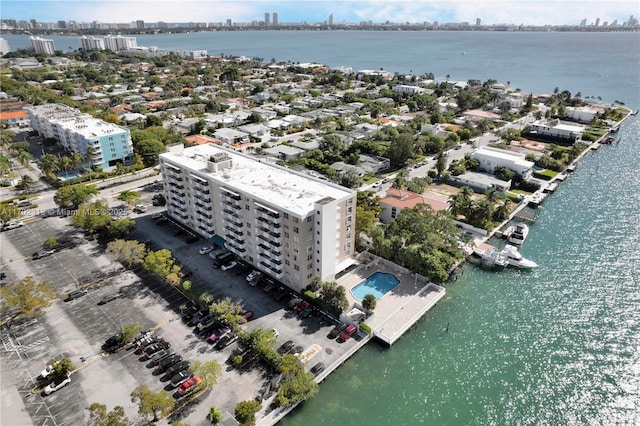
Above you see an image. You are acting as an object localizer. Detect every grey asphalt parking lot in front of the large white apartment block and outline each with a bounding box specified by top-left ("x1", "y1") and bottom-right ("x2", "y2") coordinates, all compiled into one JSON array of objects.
[{"x1": 0, "y1": 205, "x2": 362, "y2": 425}]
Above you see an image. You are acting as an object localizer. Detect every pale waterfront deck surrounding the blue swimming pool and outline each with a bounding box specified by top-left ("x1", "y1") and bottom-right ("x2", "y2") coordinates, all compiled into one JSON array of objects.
[{"x1": 337, "y1": 253, "x2": 445, "y2": 345}]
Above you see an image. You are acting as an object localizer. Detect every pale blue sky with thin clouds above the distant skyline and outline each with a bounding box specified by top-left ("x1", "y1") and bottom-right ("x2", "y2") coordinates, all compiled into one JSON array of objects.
[{"x1": 0, "y1": 0, "x2": 640, "y2": 25}]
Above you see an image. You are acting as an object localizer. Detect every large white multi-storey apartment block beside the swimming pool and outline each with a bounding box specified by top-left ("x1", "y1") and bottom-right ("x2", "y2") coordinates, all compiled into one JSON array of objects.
[{"x1": 160, "y1": 144, "x2": 357, "y2": 291}]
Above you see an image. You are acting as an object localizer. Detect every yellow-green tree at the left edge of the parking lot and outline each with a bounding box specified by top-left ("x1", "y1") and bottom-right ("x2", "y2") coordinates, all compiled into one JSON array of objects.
[{"x1": 0, "y1": 275, "x2": 56, "y2": 318}]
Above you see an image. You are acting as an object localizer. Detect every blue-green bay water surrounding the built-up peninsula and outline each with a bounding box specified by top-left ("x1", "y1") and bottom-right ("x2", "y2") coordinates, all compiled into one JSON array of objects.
[{"x1": 3, "y1": 32, "x2": 640, "y2": 426}]
